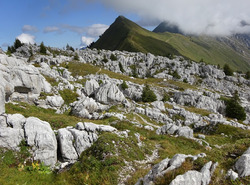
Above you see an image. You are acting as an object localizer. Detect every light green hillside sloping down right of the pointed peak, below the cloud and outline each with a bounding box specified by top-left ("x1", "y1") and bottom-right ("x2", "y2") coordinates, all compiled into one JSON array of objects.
[{"x1": 155, "y1": 32, "x2": 250, "y2": 71}]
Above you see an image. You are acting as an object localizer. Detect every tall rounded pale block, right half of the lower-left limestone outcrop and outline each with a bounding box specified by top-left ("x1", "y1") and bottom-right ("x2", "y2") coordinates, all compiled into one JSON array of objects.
[{"x1": 24, "y1": 117, "x2": 57, "y2": 166}]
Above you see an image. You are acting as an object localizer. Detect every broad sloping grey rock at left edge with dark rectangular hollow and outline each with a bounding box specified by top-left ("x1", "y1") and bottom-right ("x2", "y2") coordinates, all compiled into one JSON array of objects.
[{"x1": 0, "y1": 54, "x2": 51, "y2": 99}]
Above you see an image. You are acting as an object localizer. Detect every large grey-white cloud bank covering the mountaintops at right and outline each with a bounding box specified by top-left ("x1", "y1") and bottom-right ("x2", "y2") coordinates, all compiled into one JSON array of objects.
[{"x1": 97, "y1": 0, "x2": 250, "y2": 35}]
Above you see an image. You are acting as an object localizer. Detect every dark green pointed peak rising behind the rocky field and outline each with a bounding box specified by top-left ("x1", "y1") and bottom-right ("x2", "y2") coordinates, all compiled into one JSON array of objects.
[{"x1": 92, "y1": 16, "x2": 180, "y2": 56}]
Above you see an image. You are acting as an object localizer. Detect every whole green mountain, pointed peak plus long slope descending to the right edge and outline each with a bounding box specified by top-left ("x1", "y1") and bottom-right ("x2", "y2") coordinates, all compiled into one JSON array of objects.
[{"x1": 92, "y1": 16, "x2": 250, "y2": 71}]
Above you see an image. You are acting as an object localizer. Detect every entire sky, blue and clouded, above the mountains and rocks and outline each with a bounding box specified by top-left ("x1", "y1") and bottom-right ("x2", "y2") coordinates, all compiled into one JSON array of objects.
[{"x1": 0, "y1": 0, "x2": 250, "y2": 49}]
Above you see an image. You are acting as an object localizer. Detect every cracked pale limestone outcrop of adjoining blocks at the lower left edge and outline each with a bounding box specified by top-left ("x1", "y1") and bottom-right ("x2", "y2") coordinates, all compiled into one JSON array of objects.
[{"x1": 0, "y1": 114, "x2": 57, "y2": 166}]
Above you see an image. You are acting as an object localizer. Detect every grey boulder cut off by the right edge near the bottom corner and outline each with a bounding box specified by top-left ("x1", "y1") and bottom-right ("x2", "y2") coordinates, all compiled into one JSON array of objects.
[{"x1": 234, "y1": 147, "x2": 250, "y2": 177}]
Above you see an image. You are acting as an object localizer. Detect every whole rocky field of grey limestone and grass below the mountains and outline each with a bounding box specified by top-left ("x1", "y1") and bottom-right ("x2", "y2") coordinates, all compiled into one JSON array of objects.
[{"x1": 0, "y1": 44, "x2": 250, "y2": 185}]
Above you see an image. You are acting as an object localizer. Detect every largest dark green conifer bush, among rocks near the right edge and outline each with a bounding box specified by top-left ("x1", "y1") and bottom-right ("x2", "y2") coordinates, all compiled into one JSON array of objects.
[{"x1": 226, "y1": 91, "x2": 246, "y2": 120}]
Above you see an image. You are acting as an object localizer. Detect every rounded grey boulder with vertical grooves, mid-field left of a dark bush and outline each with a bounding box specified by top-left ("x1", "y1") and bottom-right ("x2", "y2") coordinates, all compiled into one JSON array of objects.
[{"x1": 95, "y1": 83, "x2": 125, "y2": 104}]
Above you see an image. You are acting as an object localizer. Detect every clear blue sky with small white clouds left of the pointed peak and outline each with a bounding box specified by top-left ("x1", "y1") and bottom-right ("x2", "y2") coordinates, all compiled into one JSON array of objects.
[{"x1": 0, "y1": 0, "x2": 141, "y2": 49}]
